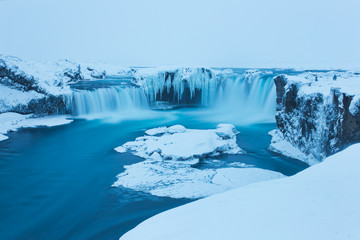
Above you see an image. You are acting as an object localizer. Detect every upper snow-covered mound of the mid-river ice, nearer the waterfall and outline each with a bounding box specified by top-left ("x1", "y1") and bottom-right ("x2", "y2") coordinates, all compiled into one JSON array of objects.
[{"x1": 115, "y1": 124, "x2": 242, "y2": 160}]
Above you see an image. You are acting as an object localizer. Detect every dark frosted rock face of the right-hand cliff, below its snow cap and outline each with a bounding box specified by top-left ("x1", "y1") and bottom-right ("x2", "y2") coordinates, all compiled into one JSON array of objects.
[{"x1": 274, "y1": 76, "x2": 360, "y2": 160}]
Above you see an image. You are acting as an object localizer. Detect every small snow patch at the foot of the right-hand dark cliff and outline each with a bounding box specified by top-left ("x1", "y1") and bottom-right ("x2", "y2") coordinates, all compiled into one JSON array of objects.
[{"x1": 269, "y1": 129, "x2": 319, "y2": 165}]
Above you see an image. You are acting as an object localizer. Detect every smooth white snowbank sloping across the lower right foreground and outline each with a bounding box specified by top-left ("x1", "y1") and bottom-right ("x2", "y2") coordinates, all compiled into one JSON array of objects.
[{"x1": 120, "y1": 144, "x2": 360, "y2": 240}]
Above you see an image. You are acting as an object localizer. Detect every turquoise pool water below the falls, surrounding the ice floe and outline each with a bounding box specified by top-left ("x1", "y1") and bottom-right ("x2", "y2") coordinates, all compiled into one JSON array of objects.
[{"x1": 0, "y1": 109, "x2": 307, "y2": 240}]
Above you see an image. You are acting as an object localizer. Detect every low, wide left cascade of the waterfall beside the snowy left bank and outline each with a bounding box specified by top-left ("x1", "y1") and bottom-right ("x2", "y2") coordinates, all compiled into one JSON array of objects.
[{"x1": 66, "y1": 86, "x2": 148, "y2": 116}]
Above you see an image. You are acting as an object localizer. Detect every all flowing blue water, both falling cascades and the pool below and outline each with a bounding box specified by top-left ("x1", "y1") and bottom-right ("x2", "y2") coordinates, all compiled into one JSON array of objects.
[{"x1": 0, "y1": 68, "x2": 307, "y2": 240}]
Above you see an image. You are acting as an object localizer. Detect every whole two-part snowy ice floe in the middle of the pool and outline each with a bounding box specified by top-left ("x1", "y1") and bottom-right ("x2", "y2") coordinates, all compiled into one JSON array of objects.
[{"x1": 113, "y1": 124, "x2": 283, "y2": 198}]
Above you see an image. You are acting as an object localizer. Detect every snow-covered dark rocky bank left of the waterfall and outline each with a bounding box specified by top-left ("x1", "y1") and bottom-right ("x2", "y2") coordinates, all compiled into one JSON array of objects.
[{"x1": 0, "y1": 54, "x2": 130, "y2": 116}]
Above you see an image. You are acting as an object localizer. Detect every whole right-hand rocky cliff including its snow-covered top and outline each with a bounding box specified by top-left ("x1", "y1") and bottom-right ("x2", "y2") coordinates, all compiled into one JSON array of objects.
[{"x1": 274, "y1": 72, "x2": 360, "y2": 160}]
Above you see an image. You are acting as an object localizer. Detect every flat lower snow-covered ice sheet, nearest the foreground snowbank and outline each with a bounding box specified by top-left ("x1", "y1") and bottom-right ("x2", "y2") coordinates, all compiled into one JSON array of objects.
[{"x1": 113, "y1": 159, "x2": 283, "y2": 198}]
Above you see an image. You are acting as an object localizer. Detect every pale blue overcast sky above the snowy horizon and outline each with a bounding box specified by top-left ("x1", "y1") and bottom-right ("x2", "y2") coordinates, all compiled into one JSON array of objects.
[{"x1": 0, "y1": 0, "x2": 360, "y2": 68}]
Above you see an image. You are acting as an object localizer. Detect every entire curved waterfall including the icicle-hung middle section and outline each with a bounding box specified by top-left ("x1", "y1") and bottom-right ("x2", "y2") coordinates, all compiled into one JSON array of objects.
[{"x1": 66, "y1": 68, "x2": 276, "y2": 122}]
